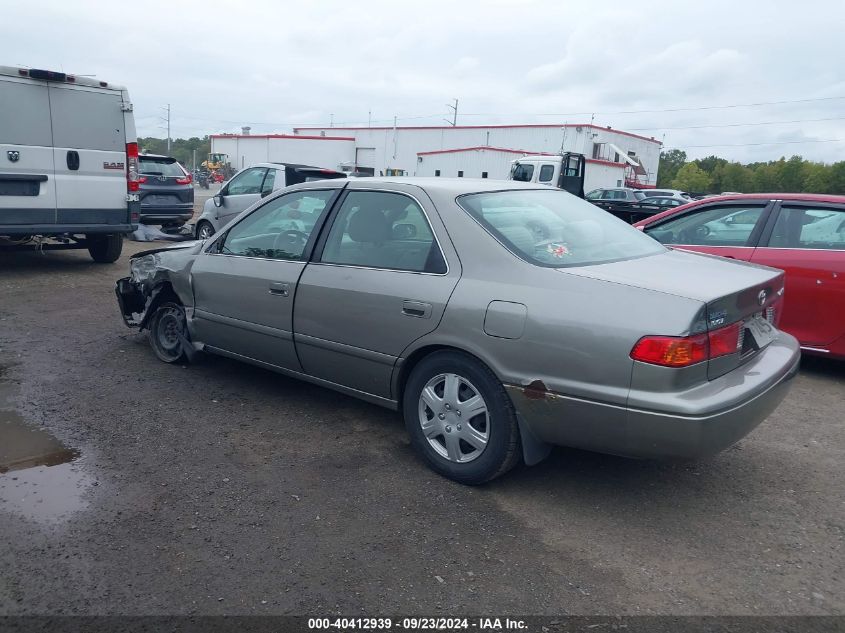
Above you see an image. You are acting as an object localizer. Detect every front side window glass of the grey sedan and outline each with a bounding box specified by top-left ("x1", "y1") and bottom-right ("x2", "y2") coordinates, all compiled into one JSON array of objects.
[{"x1": 218, "y1": 190, "x2": 334, "y2": 261}]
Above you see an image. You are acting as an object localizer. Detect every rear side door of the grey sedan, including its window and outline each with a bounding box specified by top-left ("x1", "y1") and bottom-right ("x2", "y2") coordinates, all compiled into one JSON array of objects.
[{"x1": 294, "y1": 185, "x2": 460, "y2": 398}]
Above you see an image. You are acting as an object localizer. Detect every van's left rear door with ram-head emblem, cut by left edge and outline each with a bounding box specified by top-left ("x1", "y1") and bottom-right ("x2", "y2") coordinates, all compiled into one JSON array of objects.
[{"x1": 0, "y1": 75, "x2": 56, "y2": 228}]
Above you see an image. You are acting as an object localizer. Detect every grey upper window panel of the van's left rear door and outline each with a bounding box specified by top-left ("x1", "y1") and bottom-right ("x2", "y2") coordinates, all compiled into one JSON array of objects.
[{"x1": 0, "y1": 78, "x2": 53, "y2": 146}]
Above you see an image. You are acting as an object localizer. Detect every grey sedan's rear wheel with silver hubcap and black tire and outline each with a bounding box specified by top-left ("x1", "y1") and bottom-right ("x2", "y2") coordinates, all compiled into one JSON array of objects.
[{"x1": 402, "y1": 351, "x2": 522, "y2": 485}]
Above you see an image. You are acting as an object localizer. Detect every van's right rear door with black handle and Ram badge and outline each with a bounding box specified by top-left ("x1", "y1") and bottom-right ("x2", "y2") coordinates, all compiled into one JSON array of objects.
[{"x1": 50, "y1": 83, "x2": 127, "y2": 232}]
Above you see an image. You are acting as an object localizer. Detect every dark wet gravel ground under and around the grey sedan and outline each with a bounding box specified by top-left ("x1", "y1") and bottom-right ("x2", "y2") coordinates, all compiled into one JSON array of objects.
[{"x1": 0, "y1": 235, "x2": 845, "y2": 615}]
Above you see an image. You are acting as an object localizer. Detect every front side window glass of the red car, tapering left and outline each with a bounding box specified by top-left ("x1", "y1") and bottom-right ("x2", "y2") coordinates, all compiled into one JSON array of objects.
[{"x1": 645, "y1": 204, "x2": 765, "y2": 246}]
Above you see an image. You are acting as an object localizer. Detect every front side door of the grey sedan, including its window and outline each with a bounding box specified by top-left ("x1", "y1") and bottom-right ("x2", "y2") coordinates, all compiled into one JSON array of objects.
[{"x1": 191, "y1": 188, "x2": 340, "y2": 371}]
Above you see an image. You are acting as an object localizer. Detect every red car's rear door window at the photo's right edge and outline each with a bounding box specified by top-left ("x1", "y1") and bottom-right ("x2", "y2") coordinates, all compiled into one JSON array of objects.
[{"x1": 769, "y1": 207, "x2": 845, "y2": 251}]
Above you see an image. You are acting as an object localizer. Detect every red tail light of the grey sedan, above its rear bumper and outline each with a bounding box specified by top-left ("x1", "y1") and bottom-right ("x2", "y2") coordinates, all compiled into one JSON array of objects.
[{"x1": 631, "y1": 323, "x2": 742, "y2": 367}]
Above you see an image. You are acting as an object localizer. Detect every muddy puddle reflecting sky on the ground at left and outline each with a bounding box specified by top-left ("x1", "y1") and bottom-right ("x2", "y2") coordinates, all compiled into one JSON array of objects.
[{"x1": 0, "y1": 410, "x2": 96, "y2": 523}]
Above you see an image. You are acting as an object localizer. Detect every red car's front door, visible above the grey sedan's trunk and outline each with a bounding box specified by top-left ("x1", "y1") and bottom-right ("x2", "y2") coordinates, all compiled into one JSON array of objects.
[{"x1": 645, "y1": 200, "x2": 772, "y2": 261}]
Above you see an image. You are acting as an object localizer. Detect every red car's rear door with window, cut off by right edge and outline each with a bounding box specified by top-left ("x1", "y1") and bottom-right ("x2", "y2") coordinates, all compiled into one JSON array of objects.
[{"x1": 751, "y1": 201, "x2": 845, "y2": 347}]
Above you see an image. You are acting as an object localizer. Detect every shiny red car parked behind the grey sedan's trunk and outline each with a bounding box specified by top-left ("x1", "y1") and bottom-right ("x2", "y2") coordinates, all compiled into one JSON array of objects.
[{"x1": 634, "y1": 193, "x2": 845, "y2": 359}]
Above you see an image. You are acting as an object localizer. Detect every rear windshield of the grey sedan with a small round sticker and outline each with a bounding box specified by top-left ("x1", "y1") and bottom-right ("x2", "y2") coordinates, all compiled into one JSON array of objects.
[{"x1": 458, "y1": 189, "x2": 666, "y2": 268}]
